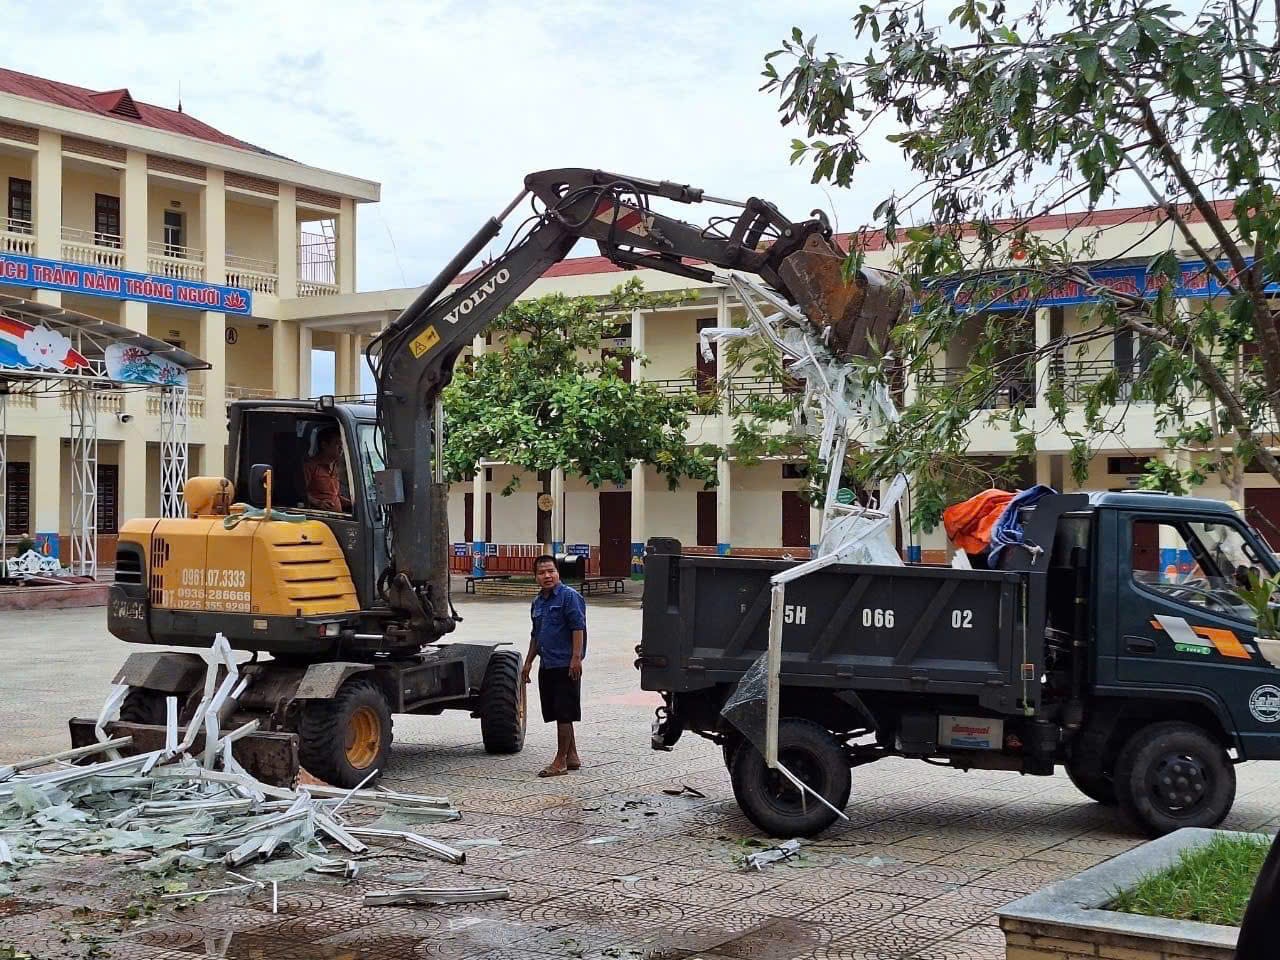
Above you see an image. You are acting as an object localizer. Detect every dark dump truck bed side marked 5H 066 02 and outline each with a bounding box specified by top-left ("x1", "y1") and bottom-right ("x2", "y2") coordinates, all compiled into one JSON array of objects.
[{"x1": 640, "y1": 540, "x2": 1043, "y2": 714}]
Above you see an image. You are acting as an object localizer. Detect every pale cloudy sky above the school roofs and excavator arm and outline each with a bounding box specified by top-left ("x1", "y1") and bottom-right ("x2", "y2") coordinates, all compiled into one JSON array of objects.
[{"x1": 0, "y1": 0, "x2": 911, "y2": 291}]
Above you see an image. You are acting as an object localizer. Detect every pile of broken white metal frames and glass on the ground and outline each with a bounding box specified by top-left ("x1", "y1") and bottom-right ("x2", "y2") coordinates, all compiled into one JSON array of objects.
[{"x1": 0, "y1": 635, "x2": 507, "y2": 905}]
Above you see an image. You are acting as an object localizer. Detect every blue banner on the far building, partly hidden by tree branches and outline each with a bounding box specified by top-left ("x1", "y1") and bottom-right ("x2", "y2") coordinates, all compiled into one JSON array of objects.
[{"x1": 943, "y1": 260, "x2": 1259, "y2": 310}]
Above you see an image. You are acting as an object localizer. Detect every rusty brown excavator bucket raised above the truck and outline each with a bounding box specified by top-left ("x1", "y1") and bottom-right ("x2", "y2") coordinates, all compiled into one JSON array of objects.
[{"x1": 778, "y1": 234, "x2": 906, "y2": 360}]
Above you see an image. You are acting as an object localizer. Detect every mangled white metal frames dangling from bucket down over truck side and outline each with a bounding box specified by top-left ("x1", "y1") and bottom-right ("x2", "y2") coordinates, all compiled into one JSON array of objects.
[{"x1": 700, "y1": 274, "x2": 908, "y2": 798}]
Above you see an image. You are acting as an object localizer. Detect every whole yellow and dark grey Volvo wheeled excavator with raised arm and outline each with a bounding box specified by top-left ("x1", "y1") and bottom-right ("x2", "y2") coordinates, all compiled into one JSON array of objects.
[{"x1": 70, "y1": 168, "x2": 902, "y2": 787}]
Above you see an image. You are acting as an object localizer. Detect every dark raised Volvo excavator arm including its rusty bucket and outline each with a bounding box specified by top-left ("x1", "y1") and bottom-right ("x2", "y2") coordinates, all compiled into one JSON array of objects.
[{"x1": 369, "y1": 168, "x2": 901, "y2": 643}]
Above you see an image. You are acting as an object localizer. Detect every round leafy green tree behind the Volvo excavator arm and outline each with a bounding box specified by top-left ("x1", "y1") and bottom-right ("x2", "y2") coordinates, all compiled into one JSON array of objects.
[{"x1": 444, "y1": 273, "x2": 718, "y2": 494}]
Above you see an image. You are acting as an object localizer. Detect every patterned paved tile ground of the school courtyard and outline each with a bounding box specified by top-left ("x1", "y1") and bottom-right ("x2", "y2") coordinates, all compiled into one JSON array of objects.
[{"x1": 0, "y1": 591, "x2": 1280, "y2": 960}]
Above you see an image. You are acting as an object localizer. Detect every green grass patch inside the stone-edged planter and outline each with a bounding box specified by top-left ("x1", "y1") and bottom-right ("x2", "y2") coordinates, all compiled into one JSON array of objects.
[{"x1": 1107, "y1": 836, "x2": 1271, "y2": 927}]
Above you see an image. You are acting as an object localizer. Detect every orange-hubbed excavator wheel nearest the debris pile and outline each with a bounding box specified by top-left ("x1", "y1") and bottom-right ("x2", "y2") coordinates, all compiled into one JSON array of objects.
[{"x1": 298, "y1": 677, "x2": 392, "y2": 787}]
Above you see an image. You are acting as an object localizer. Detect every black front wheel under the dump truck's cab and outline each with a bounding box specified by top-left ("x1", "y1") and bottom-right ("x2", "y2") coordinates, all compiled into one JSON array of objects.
[{"x1": 1115, "y1": 721, "x2": 1235, "y2": 836}]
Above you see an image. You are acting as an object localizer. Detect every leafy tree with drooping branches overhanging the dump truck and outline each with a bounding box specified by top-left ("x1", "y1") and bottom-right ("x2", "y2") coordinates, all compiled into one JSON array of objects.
[{"x1": 763, "y1": 0, "x2": 1280, "y2": 525}]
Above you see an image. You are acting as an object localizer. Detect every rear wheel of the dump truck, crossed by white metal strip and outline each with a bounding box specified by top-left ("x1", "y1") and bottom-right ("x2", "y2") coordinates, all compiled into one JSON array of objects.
[{"x1": 730, "y1": 719, "x2": 852, "y2": 837}]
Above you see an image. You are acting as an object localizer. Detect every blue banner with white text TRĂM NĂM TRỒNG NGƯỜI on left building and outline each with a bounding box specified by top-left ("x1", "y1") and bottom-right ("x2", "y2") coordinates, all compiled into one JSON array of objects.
[{"x1": 0, "y1": 253, "x2": 253, "y2": 316}]
